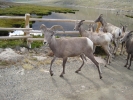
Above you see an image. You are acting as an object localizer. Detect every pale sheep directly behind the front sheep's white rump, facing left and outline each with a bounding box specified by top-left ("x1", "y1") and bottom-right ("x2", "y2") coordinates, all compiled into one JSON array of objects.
[{"x1": 74, "y1": 20, "x2": 112, "y2": 64}]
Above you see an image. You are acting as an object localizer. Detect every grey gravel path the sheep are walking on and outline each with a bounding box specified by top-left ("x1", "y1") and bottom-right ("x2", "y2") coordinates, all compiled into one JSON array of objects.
[{"x1": 0, "y1": 56, "x2": 133, "y2": 100}]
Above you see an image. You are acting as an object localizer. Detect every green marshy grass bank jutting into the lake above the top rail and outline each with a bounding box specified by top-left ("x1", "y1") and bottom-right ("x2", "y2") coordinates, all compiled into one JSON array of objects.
[{"x1": 0, "y1": 4, "x2": 75, "y2": 16}]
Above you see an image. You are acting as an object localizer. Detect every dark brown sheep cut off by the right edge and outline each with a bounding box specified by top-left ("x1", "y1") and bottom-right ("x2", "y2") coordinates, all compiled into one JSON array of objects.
[{"x1": 120, "y1": 31, "x2": 133, "y2": 69}]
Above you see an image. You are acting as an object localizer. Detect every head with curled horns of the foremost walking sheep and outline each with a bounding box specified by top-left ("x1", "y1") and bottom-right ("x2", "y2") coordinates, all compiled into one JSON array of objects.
[{"x1": 40, "y1": 24, "x2": 65, "y2": 44}]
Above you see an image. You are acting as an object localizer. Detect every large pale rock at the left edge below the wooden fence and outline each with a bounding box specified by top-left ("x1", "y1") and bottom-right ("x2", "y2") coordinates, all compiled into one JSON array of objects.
[{"x1": 0, "y1": 48, "x2": 24, "y2": 63}]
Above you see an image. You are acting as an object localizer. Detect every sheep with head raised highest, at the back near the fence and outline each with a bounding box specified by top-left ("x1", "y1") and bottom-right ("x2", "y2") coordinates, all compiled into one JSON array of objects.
[{"x1": 95, "y1": 14, "x2": 126, "y2": 54}]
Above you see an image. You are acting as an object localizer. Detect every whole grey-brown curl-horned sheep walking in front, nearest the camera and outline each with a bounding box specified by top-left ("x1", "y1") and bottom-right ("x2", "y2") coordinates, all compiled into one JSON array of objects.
[{"x1": 40, "y1": 24, "x2": 102, "y2": 79}]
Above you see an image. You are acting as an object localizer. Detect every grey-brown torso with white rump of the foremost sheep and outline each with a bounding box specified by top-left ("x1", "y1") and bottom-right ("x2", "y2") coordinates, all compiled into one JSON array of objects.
[{"x1": 53, "y1": 37, "x2": 93, "y2": 57}]
